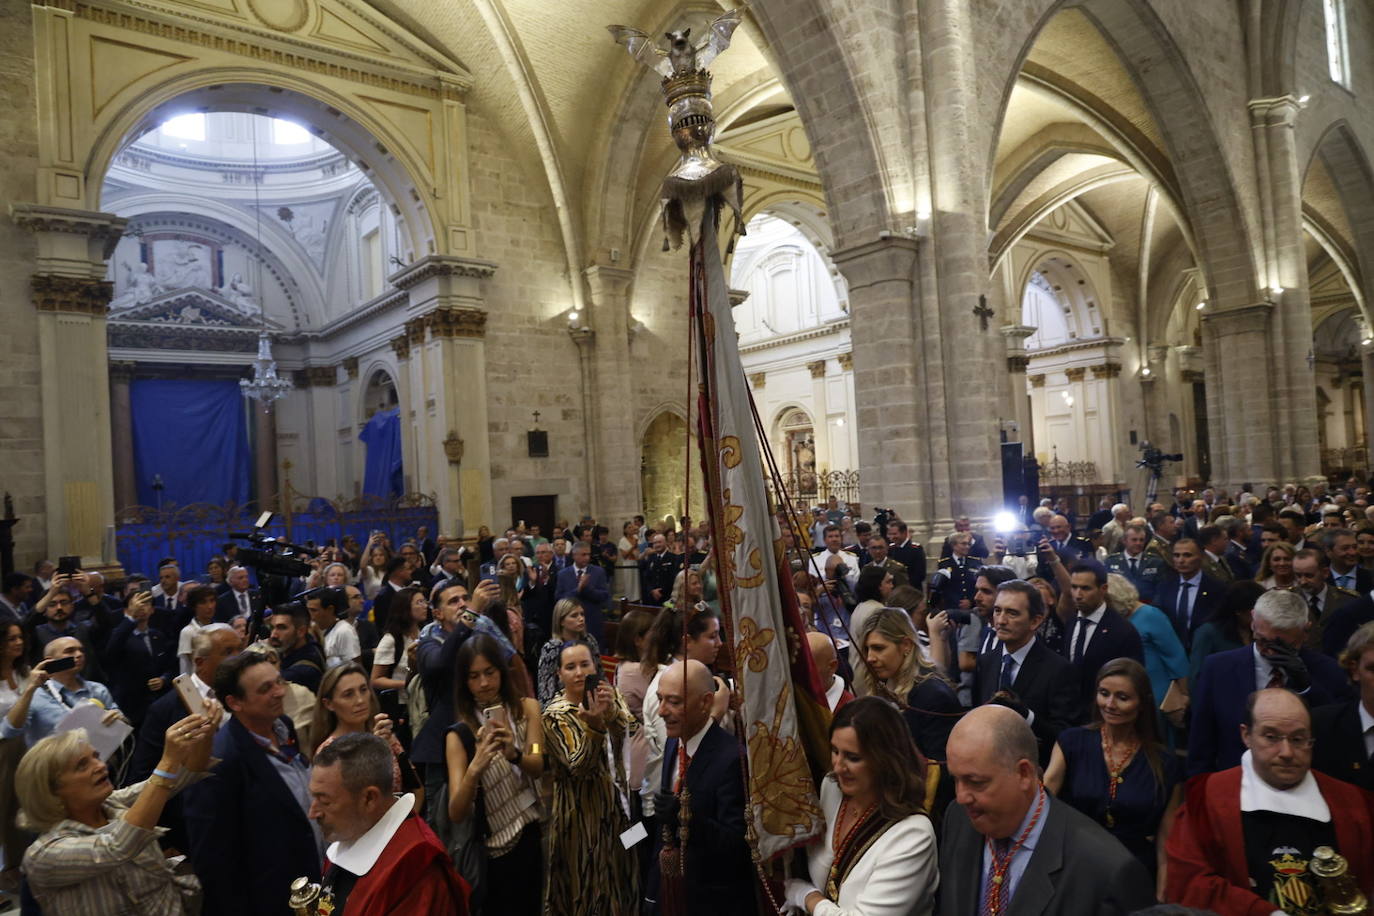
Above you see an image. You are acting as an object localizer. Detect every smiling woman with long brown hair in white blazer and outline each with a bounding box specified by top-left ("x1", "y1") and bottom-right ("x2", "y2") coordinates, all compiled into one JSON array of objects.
[{"x1": 786, "y1": 696, "x2": 940, "y2": 916}]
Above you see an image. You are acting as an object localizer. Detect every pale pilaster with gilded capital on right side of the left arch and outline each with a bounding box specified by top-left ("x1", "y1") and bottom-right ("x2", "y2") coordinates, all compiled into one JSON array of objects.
[{"x1": 390, "y1": 255, "x2": 496, "y2": 536}]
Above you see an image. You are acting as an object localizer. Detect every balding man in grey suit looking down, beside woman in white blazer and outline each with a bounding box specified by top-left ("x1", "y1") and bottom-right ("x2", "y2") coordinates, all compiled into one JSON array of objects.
[{"x1": 940, "y1": 706, "x2": 1154, "y2": 916}]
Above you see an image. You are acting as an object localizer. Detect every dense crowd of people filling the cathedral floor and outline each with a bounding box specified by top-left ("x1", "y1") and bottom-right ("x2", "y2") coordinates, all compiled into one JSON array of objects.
[{"x1": 0, "y1": 481, "x2": 1374, "y2": 916}]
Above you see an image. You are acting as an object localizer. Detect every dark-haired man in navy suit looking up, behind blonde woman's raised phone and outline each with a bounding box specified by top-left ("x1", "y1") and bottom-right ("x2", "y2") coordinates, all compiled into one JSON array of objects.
[{"x1": 185, "y1": 652, "x2": 323, "y2": 916}]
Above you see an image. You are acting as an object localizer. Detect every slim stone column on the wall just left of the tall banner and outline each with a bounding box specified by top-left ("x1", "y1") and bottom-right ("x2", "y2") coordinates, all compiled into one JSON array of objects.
[{"x1": 584, "y1": 264, "x2": 640, "y2": 529}]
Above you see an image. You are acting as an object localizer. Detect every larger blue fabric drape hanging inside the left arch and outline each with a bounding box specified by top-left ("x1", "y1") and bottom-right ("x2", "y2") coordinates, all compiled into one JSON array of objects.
[{"x1": 129, "y1": 379, "x2": 253, "y2": 505}]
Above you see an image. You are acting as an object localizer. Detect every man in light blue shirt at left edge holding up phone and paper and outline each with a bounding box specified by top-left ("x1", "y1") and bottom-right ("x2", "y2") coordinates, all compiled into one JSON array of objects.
[{"x1": 0, "y1": 636, "x2": 131, "y2": 747}]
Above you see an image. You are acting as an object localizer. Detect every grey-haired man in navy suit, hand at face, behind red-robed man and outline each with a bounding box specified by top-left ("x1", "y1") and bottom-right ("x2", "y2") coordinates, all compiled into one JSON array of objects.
[{"x1": 1187, "y1": 591, "x2": 1352, "y2": 776}]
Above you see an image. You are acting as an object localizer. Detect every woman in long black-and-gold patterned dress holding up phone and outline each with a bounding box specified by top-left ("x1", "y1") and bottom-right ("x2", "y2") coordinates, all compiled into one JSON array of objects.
[{"x1": 544, "y1": 641, "x2": 639, "y2": 916}]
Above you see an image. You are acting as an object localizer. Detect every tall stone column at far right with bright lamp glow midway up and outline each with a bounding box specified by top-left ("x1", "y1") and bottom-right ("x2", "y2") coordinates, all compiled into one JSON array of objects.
[{"x1": 1253, "y1": 96, "x2": 1322, "y2": 483}]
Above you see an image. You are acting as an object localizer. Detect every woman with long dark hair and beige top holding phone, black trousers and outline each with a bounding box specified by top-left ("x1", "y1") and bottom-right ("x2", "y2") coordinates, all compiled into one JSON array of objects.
[{"x1": 444, "y1": 634, "x2": 544, "y2": 916}]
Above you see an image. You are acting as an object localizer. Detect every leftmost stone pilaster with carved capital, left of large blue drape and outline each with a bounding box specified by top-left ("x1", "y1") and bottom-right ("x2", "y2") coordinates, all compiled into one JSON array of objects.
[{"x1": 10, "y1": 203, "x2": 128, "y2": 567}]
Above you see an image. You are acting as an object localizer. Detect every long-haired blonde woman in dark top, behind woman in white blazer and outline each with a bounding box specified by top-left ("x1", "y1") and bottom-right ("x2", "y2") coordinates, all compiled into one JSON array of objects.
[{"x1": 855, "y1": 607, "x2": 963, "y2": 762}]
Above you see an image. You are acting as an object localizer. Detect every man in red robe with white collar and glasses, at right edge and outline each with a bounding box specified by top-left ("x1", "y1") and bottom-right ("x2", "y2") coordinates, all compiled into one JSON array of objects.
[{"x1": 1164, "y1": 688, "x2": 1374, "y2": 916}]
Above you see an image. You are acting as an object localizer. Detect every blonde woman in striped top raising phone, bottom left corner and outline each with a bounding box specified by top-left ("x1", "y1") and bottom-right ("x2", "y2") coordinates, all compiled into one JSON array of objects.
[{"x1": 15, "y1": 700, "x2": 221, "y2": 916}]
